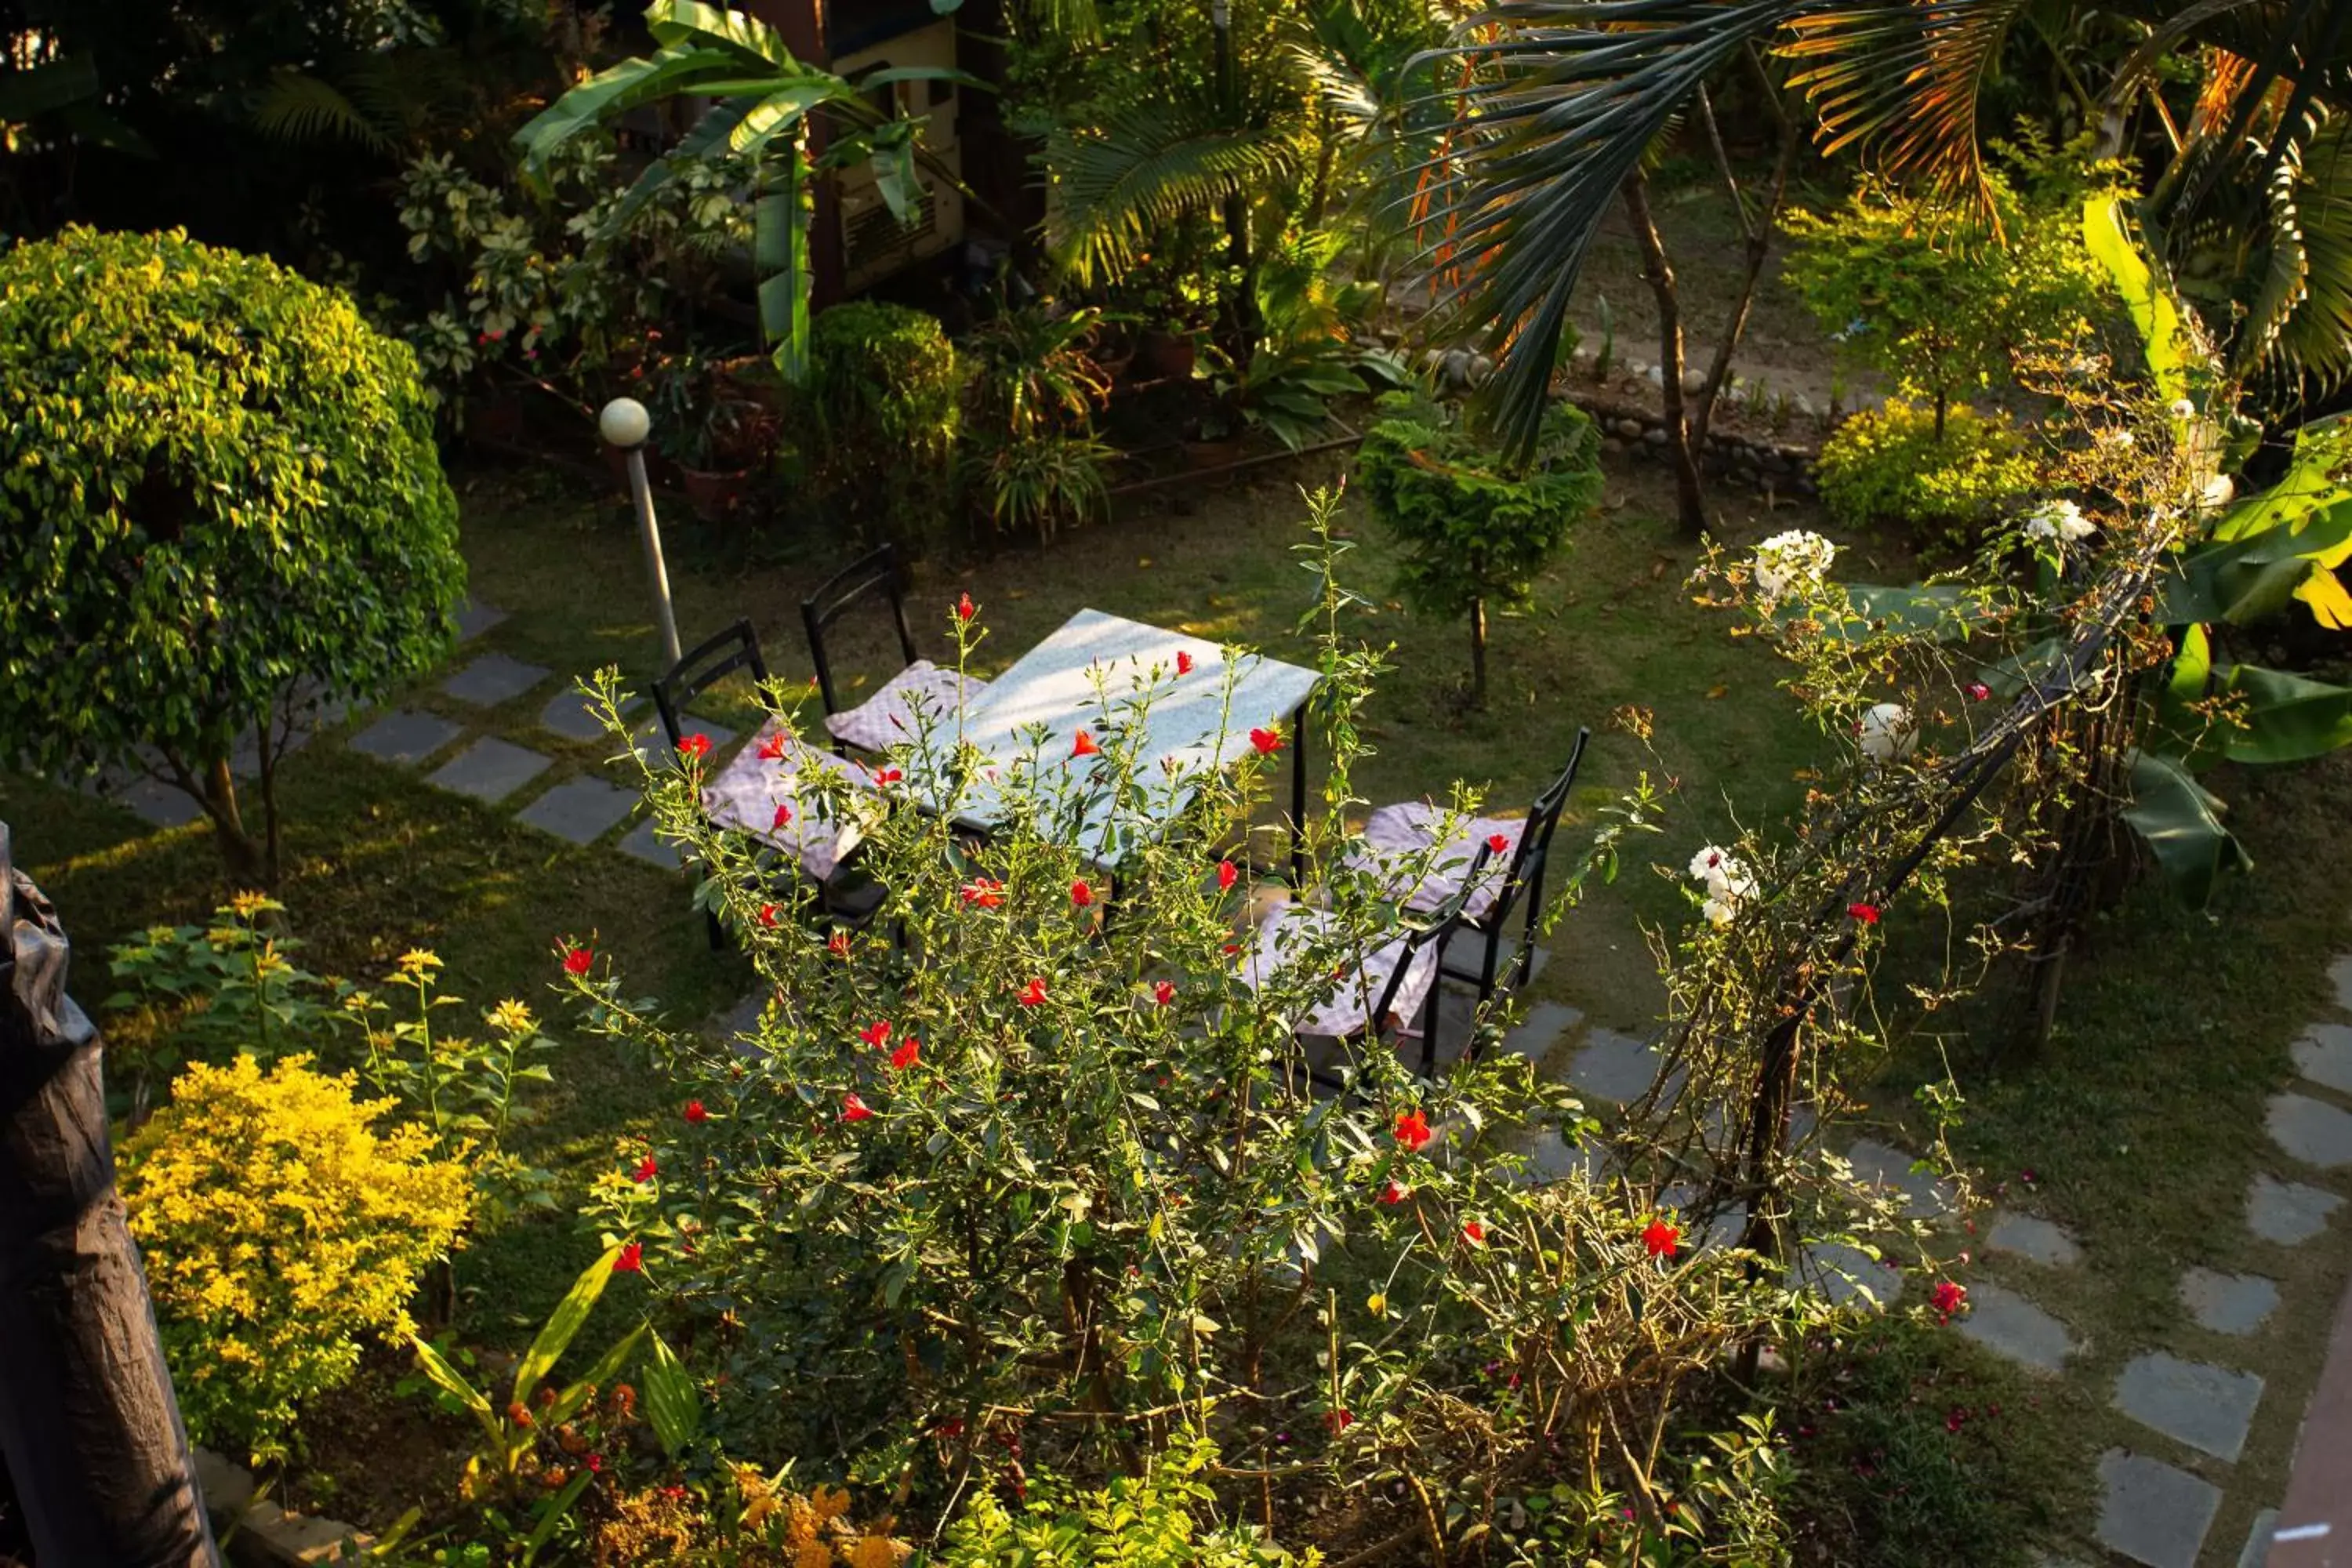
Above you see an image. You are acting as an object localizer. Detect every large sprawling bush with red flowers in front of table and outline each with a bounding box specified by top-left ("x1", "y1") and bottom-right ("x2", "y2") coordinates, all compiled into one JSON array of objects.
[{"x1": 562, "y1": 496, "x2": 1811, "y2": 1561}]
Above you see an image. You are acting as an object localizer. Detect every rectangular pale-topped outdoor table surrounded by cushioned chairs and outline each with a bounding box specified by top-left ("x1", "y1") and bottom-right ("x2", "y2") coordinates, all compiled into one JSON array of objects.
[{"x1": 906, "y1": 609, "x2": 1322, "y2": 862}]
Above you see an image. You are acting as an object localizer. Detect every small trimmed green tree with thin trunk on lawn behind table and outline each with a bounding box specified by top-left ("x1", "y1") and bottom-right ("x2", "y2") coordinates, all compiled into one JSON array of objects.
[{"x1": 1355, "y1": 393, "x2": 1602, "y2": 708}]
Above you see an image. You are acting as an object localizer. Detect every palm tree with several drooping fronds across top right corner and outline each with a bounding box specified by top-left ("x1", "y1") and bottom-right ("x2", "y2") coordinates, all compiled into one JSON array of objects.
[{"x1": 1449, "y1": 0, "x2": 2352, "y2": 449}]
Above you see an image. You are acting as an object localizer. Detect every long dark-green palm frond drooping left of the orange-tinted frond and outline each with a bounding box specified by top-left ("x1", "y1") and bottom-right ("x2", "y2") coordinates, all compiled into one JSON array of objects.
[{"x1": 1432, "y1": 0, "x2": 1820, "y2": 452}]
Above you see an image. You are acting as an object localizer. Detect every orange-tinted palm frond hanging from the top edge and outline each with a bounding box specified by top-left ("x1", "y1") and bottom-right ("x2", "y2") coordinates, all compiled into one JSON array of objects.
[{"x1": 1778, "y1": 0, "x2": 2025, "y2": 221}]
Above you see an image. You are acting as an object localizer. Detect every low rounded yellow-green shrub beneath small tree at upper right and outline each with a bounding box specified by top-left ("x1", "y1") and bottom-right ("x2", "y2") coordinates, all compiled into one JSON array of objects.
[{"x1": 1816, "y1": 397, "x2": 2034, "y2": 555}]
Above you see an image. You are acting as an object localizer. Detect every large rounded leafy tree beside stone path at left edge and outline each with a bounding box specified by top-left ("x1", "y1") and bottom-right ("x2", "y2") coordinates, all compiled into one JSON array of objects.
[{"x1": 0, "y1": 228, "x2": 466, "y2": 881}]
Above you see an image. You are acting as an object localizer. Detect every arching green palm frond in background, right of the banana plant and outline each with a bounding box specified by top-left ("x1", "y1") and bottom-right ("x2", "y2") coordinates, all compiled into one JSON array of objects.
[{"x1": 1047, "y1": 101, "x2": 1291, "y2": 285}]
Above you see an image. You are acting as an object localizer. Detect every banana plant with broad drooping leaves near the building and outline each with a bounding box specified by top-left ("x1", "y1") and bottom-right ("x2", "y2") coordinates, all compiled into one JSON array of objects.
[{"x1": 515, "y1": 0, "x2": 985, "y2": 386}]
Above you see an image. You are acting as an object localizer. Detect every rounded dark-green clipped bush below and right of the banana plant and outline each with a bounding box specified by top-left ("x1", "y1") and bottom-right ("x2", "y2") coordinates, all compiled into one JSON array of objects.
[{"x1": 802, "y1": 301, "x2": 962, "y2": 546}]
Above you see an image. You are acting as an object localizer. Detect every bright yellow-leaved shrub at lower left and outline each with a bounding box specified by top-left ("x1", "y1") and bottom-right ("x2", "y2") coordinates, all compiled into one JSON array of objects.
[{"x1": 122, "y1": 1055, "x2": 470, "y2": 1457}]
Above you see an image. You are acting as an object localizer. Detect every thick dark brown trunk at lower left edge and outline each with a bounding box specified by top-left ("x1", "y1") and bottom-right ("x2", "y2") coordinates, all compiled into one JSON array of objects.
[{"x1": 0, "y1": 822, "x2": 221, "y2": 1568}]
